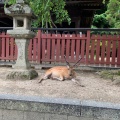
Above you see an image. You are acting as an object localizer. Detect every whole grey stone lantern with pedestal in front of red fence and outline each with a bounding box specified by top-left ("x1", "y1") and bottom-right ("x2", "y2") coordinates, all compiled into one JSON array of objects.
[{"x1": 4, "y1": 0, "x2": 38, "y2": 79}]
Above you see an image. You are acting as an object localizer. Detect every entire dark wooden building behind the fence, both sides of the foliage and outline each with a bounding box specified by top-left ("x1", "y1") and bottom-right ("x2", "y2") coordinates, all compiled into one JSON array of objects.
[{"x1": 0, "y1": 0, "x2": 104, "y2": 28}]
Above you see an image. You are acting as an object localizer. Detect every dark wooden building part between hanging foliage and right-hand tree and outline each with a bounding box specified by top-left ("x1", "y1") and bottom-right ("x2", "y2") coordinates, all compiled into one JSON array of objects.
[{"x1": 66, "y1": 0, "x2": 104, "y2": 28}]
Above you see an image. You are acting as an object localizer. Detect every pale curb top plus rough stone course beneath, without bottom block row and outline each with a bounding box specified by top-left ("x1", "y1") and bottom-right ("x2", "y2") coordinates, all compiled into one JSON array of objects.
[{"x1": 0, "y1": 94, "x2": 120, "y2": 120}]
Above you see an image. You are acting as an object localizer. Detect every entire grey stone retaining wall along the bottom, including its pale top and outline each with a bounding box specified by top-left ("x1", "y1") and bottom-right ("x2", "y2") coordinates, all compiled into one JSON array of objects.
[{"x1": 0, "y1": 95, "x2": 120, "y2": 120}]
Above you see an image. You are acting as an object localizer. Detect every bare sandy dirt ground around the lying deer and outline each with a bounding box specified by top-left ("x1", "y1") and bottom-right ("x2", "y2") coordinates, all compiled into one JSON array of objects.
[{"x1": 0, "y1": 67, "x2": 120, "y2": 103}]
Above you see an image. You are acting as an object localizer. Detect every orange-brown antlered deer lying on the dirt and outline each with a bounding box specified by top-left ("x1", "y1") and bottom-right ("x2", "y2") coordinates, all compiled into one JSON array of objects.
[{"x1": 39, "y1": 56, "x2": 82, "y2": 84}]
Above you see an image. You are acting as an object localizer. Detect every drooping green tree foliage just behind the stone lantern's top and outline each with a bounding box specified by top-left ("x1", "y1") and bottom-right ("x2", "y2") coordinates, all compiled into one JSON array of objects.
[{"x1": 8, "y1": 0, "x2": 71, "y2": 27}]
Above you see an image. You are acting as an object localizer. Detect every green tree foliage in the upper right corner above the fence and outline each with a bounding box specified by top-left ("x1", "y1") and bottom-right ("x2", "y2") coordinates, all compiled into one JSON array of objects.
[{"x1": 92, "y1": 0, "x2": 120, "y2": 28}]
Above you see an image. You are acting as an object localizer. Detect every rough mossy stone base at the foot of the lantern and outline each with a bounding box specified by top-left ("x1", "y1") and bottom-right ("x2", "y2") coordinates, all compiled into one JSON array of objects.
[{"x1": 6, "y1": 69, "x2": 38, "y2": 80}]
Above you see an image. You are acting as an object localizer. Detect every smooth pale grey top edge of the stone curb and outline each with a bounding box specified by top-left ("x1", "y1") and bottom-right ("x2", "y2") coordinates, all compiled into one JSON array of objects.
[{"x1": 0, "y1": 94, "x2": 120, "y2": 110}]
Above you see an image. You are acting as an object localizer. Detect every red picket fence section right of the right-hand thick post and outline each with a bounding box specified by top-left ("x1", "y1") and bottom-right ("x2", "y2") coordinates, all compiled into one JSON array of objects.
[{"x1": 89, "y1": 35, "x2": 120, "y2": 65}]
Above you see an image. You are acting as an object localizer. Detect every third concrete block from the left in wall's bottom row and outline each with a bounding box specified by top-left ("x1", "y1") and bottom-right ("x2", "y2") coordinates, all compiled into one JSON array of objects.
[{"x1": 45, "y1": 114, "x2": 67, "y2": 120}]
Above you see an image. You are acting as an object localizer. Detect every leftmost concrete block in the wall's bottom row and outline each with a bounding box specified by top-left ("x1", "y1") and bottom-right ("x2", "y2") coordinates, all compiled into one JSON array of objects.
[{"x1": 2, "y1": 110, "x2": 24, "y2": 120}]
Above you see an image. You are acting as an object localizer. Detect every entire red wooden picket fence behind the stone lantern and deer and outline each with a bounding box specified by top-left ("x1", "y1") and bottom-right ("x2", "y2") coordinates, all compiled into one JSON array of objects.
[{"x1": 0, "y1": 30, "x2": 120, "y2": 67}]
